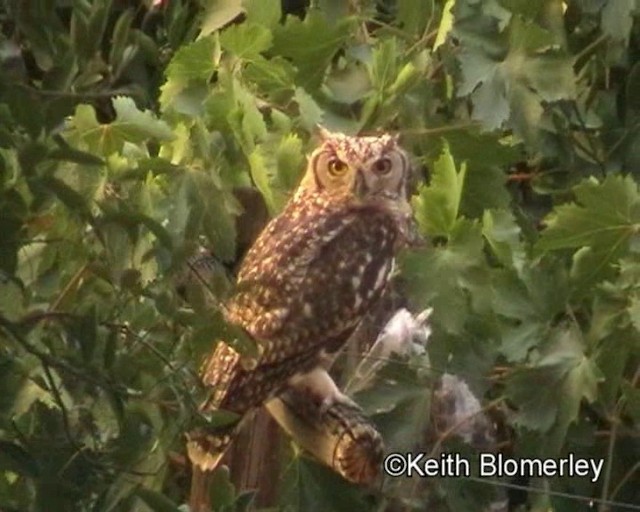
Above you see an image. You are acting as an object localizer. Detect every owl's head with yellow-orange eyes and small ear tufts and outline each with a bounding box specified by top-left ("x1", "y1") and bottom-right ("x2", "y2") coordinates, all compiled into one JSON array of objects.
[{"x1": 301, "y1": 128, "x2": 410, "y2": 201}]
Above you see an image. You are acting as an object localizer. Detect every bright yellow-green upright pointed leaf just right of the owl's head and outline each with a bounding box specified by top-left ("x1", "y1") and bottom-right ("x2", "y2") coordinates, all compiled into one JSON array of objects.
[{"x1": 413, "y1": 144, "x2": 466, "y2": 236}]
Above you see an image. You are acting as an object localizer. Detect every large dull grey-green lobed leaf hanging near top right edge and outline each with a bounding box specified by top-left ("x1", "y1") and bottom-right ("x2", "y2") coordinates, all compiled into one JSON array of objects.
[{"x1": 454, "y1": 7, "x2": 576, "y2": 145}]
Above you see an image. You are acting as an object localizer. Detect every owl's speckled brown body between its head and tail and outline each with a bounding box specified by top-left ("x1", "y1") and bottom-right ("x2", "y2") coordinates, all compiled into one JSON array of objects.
[{"x1": 228, "y1": 195, "x2": 402, "y2": 345}]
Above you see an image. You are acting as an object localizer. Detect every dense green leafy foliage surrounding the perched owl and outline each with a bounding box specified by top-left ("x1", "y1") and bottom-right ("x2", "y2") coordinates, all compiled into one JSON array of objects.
[{"x1": 0, "y1": 0, "x2": 640, "y2": 511}]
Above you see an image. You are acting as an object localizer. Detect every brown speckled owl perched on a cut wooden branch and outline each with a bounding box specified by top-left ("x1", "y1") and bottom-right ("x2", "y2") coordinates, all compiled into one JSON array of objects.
[{"x1": 187, "y1": 129, "x2": 412, "y2": 470}]
